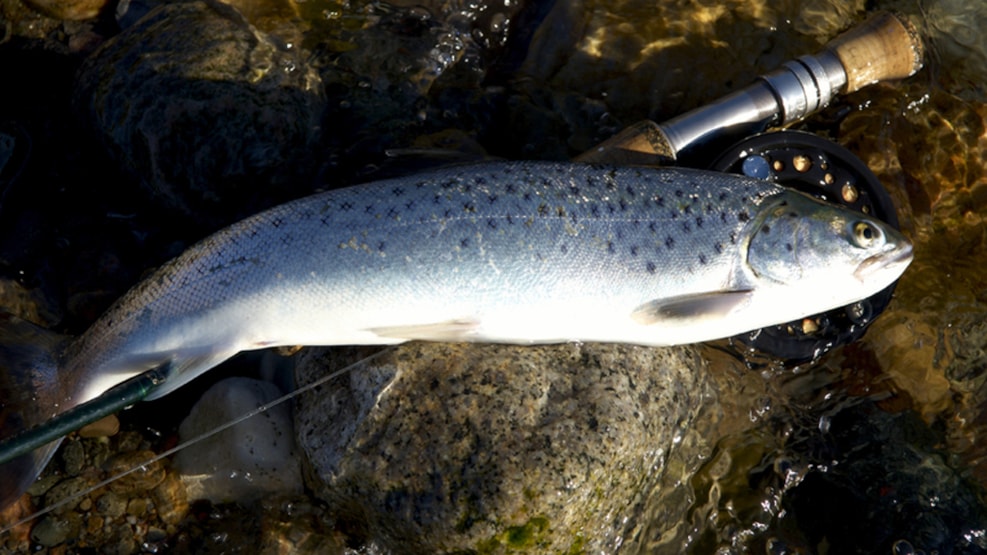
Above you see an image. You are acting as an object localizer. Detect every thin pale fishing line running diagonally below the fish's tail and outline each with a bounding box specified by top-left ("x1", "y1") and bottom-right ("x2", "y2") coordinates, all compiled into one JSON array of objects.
[{"x1": 0, "y1": 345, "x2": 396, "y2": 534}]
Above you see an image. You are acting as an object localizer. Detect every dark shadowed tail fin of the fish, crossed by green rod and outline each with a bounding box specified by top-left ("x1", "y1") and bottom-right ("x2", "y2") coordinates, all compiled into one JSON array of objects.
[{"x1": 0, "y1": 311, "x2": 69, "y2": 509}]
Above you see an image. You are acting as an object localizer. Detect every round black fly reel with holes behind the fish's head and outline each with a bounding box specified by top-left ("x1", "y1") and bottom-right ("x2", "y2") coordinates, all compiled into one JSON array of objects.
[{"x1": 710, "y1": 131, "x2": 898, "y2": 362}]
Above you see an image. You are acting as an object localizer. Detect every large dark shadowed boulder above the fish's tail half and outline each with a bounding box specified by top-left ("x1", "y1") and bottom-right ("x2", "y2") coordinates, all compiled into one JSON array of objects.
[{"x1": 75, "y1": 0, "x2": 325, "y2": 224}]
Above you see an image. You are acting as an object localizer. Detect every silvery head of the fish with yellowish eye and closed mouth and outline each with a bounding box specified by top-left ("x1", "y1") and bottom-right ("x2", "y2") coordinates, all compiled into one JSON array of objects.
[{"x1": 747, "y1": 191, "x2": 912, "y2": 312}]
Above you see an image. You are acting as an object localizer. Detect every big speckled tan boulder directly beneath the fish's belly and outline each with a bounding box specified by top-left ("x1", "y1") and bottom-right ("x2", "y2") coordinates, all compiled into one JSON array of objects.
[{"x1": 296, "y1": 343, "x2": 711, "y2": 553}]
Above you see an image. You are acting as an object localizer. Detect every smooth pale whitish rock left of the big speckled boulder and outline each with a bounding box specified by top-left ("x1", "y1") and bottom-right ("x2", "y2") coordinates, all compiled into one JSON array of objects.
[{"x1": 175, "y1": 378, "x2": 302, "y2": 503}]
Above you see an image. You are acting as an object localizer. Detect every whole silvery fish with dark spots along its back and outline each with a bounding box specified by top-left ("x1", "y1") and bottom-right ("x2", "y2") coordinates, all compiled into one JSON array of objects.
[{"x1": 0, "y1": 161, "x2": 912, "y2": 505}]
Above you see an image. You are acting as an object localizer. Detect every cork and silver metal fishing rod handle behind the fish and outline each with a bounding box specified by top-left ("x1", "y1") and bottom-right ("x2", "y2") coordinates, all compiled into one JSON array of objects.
[{"x1": 575, "y1": 12, "x2": 924, "y2": 165}]
